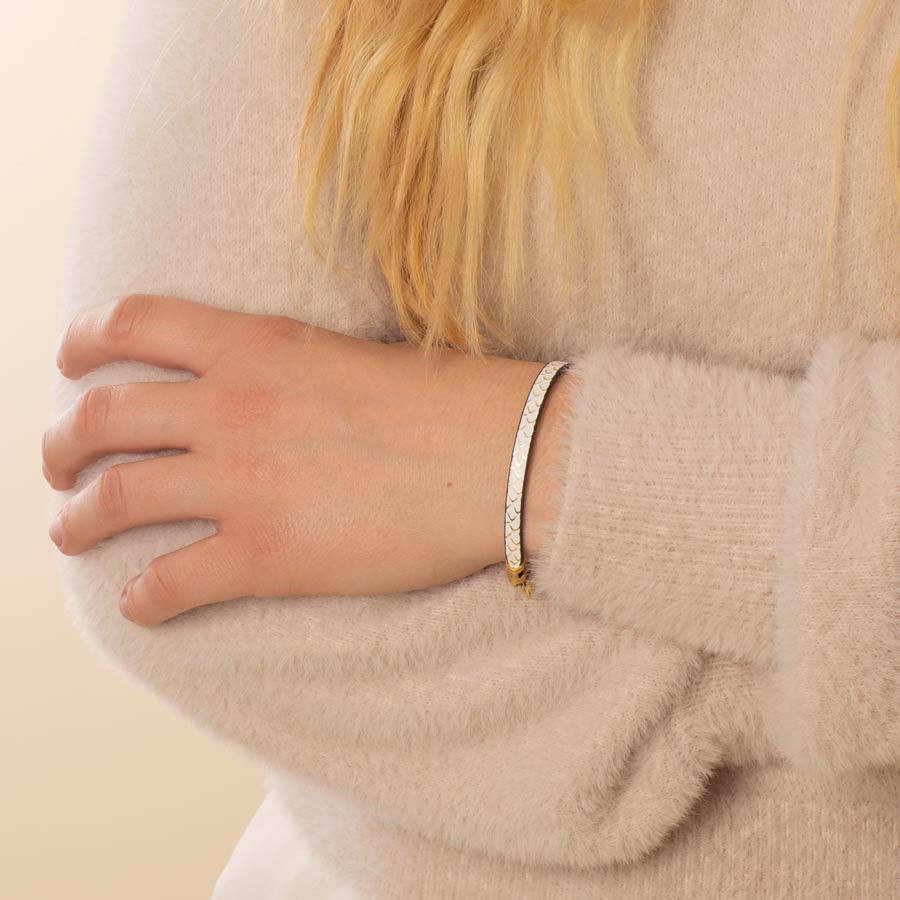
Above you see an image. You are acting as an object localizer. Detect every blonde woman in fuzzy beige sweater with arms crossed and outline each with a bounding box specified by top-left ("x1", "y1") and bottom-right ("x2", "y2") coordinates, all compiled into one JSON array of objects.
[{"x1": 44, "y1": 0, "x2": 900, "y2": 900}]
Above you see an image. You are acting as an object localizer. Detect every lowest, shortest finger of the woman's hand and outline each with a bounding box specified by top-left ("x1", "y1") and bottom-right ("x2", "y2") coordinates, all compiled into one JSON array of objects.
[{"x1": 119, "y1": 534, "x2": 249, "y2": 626}]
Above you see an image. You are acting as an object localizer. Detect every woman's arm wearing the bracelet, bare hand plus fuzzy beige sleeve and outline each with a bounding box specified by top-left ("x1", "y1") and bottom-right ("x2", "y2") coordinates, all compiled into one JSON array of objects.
[{"x1": 44, "y1": 295, "x2": 900, "y2": 780}]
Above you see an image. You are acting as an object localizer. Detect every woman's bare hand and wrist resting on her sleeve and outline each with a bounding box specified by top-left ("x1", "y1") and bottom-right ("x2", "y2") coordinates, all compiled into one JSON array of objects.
[{"x1": 42, "y1": 294, "x2": 563, "y2": 625}]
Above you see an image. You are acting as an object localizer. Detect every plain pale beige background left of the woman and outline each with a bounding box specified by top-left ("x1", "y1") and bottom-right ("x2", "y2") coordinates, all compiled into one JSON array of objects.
[{"x1": 0, "y1": 0, "x2": 264, "y2": 900}]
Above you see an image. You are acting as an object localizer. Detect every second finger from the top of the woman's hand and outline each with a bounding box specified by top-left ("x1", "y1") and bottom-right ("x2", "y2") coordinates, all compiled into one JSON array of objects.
[{"x1": 41, "y1": 380, "x2": 199, "y2": 490}]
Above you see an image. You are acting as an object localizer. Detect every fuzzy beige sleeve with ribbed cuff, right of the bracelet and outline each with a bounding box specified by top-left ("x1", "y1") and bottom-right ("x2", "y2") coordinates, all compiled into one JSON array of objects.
[{"x1": 523, "y1": 330, "x2": 900, "y2": 769}]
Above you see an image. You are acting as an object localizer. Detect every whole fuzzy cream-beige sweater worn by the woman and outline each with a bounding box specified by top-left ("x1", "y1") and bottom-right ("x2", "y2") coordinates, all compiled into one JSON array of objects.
[{"x1": 53, "y1": 0, "x2": 900, "y2": 900}]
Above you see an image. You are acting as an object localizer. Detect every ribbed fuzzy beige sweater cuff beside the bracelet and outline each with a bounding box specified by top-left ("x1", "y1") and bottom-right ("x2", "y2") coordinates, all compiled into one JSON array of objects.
[{"x1": 523, "y1": 334, "x2": 799, "y2": 662}]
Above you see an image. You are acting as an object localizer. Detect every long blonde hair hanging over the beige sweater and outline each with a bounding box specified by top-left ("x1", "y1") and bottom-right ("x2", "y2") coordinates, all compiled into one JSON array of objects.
[{"x1": 292, "y1": 0, "x2": 900, "y2": 355}]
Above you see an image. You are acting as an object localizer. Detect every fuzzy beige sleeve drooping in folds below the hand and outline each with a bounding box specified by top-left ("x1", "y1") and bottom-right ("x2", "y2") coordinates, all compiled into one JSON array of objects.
[{"x1": 59, "y1": 488, "x2": 744, "y2": 868}]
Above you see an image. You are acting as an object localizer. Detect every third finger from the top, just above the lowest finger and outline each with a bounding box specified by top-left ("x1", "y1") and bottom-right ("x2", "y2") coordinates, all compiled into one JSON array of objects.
[{"x1": 51, "y1": 453, "x2": 221, "y2": 556}]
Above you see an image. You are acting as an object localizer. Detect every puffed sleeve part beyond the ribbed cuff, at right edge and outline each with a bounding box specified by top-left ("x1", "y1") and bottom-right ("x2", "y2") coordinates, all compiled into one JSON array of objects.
[{"x1": 764, "y1": 331, "x2": 900, "y2": 771}]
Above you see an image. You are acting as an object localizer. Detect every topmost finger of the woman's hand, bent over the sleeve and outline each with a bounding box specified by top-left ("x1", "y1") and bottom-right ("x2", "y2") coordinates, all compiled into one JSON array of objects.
[{"x1": 57, "y1": 294, "x2": 238, "y2": 378}]
